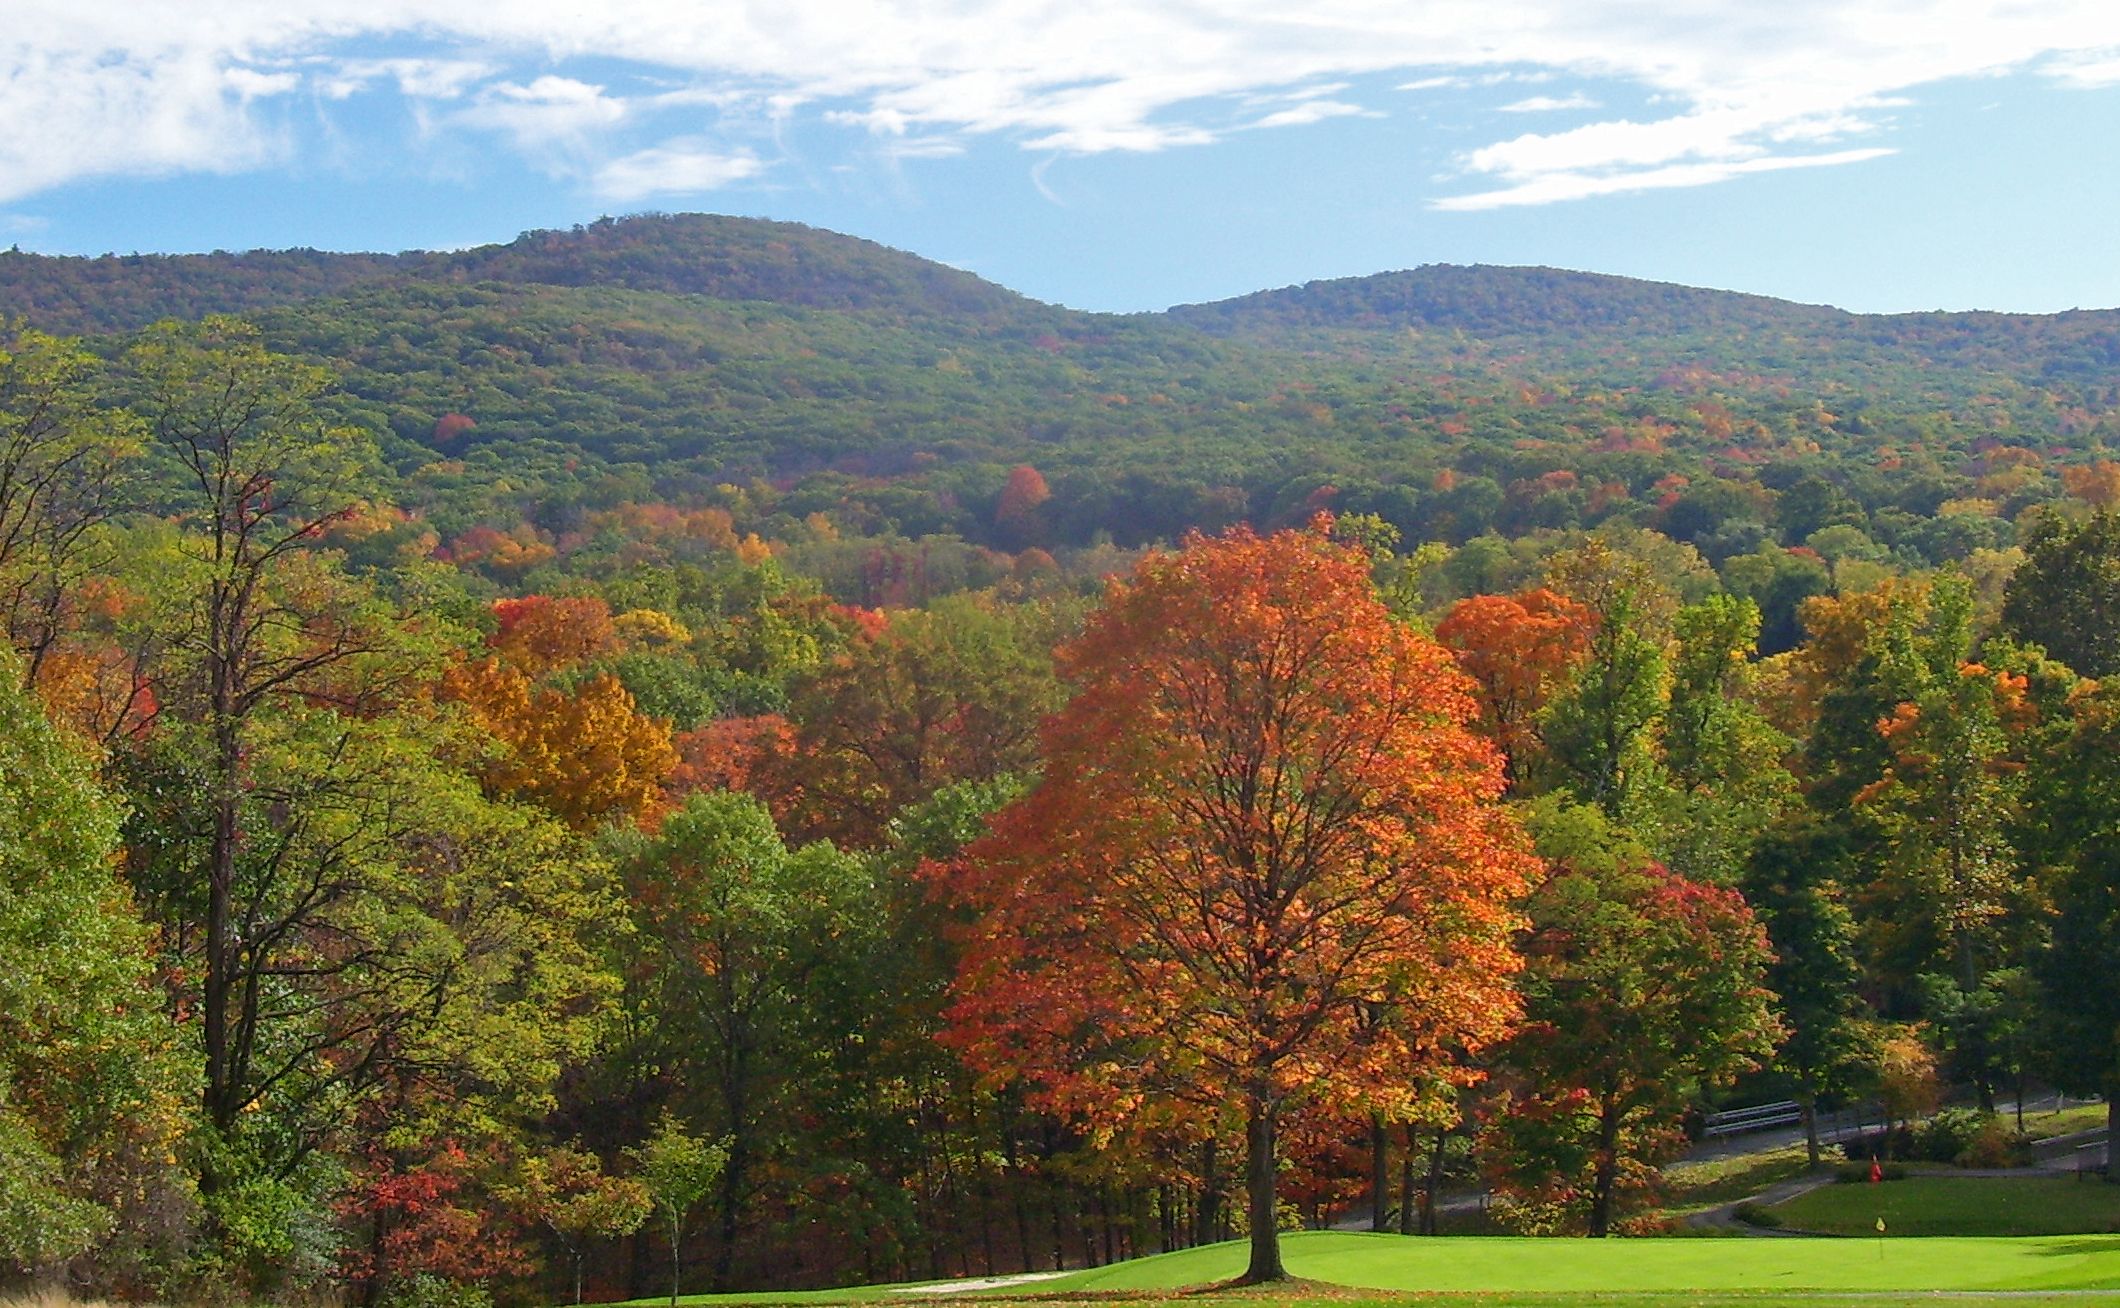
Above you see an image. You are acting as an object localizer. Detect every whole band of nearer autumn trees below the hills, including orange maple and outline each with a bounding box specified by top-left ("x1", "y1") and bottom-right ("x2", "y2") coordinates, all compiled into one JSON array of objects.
[{"x1": 0, "y1": 318, "x2": 2120, "y2": 1304}]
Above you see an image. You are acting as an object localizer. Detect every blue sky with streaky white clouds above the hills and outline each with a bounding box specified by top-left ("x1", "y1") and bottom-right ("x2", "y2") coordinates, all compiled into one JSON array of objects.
[{"x1": 12, "y1": 0, "x2": 2120, "y2": 312}]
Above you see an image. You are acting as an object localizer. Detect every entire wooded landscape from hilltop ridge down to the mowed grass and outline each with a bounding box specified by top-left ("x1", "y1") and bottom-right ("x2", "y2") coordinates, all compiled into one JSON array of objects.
[{"x1": 0, "y1": 216, "x2": 2120, "y2": 1308}]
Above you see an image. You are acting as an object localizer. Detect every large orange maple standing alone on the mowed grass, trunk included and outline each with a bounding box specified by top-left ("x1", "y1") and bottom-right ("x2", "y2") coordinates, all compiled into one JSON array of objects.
[{"x1": 931, "y1": 519, "x2": 1533, "y2": 1280}]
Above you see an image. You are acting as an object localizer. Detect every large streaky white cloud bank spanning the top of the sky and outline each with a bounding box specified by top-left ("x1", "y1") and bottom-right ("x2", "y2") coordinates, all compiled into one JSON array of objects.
[{"x1": 0, "y1": 0, "x2": 2120, "y2": 208}]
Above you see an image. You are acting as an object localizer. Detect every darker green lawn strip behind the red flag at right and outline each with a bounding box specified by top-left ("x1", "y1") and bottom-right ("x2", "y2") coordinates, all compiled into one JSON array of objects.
[{"x1": 1770, "y1": 1177, "x2": 2120, "y2": 1236}]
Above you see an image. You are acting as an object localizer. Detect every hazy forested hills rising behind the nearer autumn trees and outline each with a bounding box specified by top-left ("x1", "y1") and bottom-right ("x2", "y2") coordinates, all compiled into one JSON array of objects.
[{"x1": 0, "y1": 214, "x2": 2120, "y2": 572}]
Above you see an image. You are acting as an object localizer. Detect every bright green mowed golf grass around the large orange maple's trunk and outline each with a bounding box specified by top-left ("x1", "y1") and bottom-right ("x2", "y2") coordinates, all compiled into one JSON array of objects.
[{"x1": 644, "y1": 1229, "x2": 2120, "y2": 1308}]
